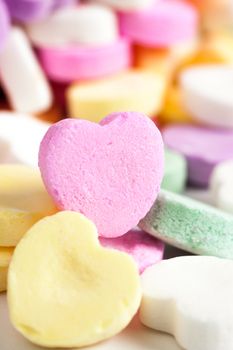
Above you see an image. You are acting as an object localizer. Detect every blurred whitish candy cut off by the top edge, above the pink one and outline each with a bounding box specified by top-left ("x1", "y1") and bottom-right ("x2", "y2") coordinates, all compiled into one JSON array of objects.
[{"x1": 92, "y1": 0, "x2": 154, "y2": 11}]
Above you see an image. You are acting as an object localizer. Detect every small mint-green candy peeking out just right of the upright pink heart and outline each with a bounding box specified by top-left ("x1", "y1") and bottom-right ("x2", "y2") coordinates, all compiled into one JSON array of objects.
[{"x1": 161, "y1": 148, "x2": 187, "y2": 193}]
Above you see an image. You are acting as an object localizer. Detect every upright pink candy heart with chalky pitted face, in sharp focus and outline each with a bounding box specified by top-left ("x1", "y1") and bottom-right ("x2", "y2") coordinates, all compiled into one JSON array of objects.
[{"x1": 39, "y1": 112, "x2": 164, "y2": 237}]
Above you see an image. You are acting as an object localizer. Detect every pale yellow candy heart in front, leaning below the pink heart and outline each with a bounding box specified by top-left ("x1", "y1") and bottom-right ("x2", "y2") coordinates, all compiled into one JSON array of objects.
[{"x1": 8, "y1": 211, "x2": 141, "y2": 347}]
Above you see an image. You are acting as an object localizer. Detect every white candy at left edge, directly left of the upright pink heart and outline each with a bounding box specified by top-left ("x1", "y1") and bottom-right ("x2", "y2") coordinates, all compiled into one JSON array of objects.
[{"x1": 0, "y1": 112, "x2": 50, "y2": 167}]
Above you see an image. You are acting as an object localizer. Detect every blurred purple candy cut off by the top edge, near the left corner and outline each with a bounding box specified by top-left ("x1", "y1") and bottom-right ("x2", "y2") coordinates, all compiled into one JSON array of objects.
[{"x1": 5, "y1": 0, "x2": 74, "y2": 23}]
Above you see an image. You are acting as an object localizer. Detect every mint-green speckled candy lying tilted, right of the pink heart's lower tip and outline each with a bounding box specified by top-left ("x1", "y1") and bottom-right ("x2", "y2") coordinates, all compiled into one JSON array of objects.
[{"x1": 139, "y1": 191, "x2": 233, "y2": 259}]
